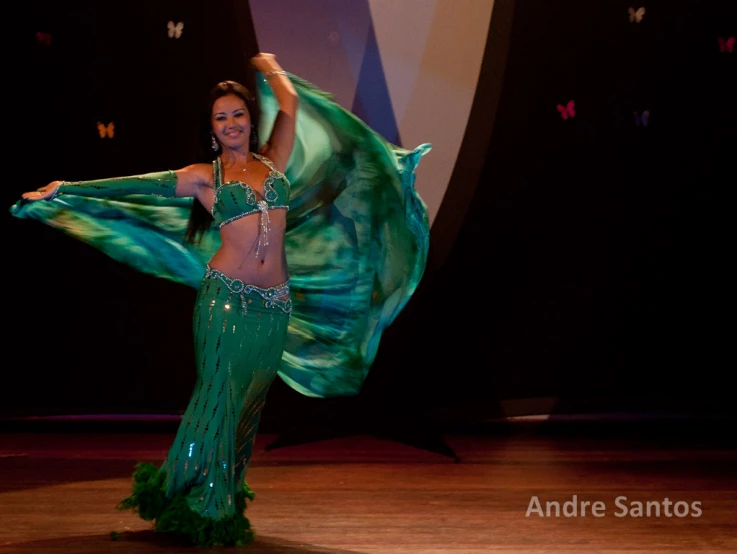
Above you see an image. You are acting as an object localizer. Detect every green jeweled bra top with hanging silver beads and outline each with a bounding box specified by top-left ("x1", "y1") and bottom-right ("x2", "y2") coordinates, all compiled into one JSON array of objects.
[{"x1": 210, "y1": 154, "x2": 289, "y2": 255}]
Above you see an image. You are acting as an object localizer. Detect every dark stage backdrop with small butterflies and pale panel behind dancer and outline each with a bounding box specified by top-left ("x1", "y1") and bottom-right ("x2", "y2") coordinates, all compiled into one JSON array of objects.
[{"x1": 1, "y1": 0, "x2": 737, "y2": 426}]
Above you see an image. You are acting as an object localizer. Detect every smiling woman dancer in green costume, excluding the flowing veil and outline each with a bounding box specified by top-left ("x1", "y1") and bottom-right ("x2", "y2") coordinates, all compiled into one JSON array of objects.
[{"x1": 22, "y1": 50, "x2": 297, "y2": 544}]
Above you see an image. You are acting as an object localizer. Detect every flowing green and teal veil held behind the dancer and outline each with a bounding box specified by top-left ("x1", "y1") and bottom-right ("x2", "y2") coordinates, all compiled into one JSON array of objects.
[{"x1": 11, "y1": 74, "x2": 430, "y2": 397}]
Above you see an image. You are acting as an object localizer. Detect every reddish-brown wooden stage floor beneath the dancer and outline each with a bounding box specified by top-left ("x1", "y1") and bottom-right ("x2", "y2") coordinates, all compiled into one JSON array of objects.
[{"x1": 0, "y1": 420, "x2": 737, "y2": 554}]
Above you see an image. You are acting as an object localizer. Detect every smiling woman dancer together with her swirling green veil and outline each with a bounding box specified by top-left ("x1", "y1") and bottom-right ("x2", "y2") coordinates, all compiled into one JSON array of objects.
[{"x1": 11, "y1": 54, "x2": 429, "y2": 546}]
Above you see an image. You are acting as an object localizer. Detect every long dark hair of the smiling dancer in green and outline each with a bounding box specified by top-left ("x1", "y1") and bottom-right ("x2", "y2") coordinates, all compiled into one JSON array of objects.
[{"x1": 184, "y1": 81, "x2": 261, "y2": 243}]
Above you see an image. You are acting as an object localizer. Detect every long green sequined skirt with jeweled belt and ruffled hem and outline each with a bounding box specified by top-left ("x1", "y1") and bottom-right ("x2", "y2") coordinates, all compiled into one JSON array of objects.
[{"x1": 118, "y1": 267, "x2": 291, "y2": 546}]
